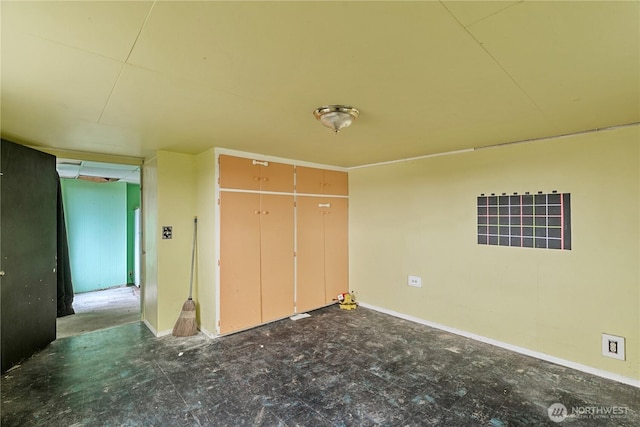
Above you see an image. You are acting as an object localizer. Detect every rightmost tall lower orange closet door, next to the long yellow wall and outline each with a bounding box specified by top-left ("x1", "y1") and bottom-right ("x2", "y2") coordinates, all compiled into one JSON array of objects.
[{"x1": 323, "y1": 197, "x2": 349, "y2": 304}]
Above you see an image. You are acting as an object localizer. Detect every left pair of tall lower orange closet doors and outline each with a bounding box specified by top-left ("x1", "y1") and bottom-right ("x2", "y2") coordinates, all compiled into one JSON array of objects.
[{"x1": 220, "y1": 192, "x2": 294, "y2": 333}]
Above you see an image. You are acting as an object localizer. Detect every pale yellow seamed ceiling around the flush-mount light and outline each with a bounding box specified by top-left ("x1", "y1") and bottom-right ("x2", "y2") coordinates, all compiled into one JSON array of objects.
[{"x1": 0, "y1": 1, "x2": 640, "y2": 167}]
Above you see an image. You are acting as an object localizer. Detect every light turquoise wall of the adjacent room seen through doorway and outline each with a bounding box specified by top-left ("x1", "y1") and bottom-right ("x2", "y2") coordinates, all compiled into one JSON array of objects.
[{"x1": 61, "y1": 179, "x2": 128, "y2": 293}]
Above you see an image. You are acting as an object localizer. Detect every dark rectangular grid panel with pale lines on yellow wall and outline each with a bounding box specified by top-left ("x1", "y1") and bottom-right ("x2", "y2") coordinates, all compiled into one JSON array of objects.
[{"x1": 478, "y1": 192, "x2": 571, "y2": 250}]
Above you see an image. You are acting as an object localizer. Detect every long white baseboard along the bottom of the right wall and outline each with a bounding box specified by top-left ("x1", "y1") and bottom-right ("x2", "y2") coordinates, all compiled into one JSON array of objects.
[{"x1": 358, "y1": 302, "x2": 640, "y2": 388}]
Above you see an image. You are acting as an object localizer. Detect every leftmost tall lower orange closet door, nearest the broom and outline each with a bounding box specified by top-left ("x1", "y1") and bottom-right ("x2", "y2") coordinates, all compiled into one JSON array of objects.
[{"x1": 220, "y1": 191, "x2": 262, "y2": 333}]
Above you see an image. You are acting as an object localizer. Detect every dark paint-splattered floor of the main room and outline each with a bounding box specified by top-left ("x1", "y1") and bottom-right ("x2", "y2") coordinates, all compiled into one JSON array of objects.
[{"x1": 1, "y1": 306, "x2": 640, "y2": 426}]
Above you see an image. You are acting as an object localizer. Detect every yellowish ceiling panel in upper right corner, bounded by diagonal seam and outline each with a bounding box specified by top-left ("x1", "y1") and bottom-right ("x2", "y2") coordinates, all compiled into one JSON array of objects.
[{"x1": 469, "y1": 2, "x2": 640, "y2": 130}]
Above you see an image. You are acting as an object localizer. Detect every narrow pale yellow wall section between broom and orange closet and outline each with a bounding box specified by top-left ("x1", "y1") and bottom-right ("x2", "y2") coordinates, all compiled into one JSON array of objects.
[{"x1": 194, "y1": 149, "x2": 216, "y2": 335}]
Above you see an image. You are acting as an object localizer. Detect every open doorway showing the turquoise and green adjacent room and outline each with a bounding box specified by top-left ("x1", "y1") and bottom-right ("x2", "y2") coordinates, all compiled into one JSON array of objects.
[{"x1": 56, "y1": 158, "x2": 142, "y2": 338}]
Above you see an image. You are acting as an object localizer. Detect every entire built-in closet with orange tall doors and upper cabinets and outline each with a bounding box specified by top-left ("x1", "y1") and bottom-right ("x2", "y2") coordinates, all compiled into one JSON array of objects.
[{"x1": 218, "y1": 155, "x2": 348, "y2": 334}]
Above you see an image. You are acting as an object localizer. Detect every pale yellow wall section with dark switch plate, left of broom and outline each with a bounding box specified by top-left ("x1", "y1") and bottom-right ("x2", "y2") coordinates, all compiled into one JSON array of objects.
[{"x1": 154, "y1": 151, "x2": 196, "y2": 334}]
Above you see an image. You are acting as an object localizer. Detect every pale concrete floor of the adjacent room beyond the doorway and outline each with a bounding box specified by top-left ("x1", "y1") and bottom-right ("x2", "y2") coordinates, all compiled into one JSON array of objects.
[{"x1": 56, "y1": 286, "x2": 140, "y2": 339}]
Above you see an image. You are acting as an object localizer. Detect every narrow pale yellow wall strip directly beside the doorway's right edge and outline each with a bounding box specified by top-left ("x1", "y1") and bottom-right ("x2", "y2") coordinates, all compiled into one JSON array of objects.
[{"x1": 141, "y1": 157, "x2": 158, "y2": 331}]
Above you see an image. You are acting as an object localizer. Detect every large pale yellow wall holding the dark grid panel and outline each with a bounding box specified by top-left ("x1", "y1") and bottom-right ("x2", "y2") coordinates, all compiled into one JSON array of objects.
[{"x1": 349, "y1": 127, "x2": 640, "y2": 379}]
